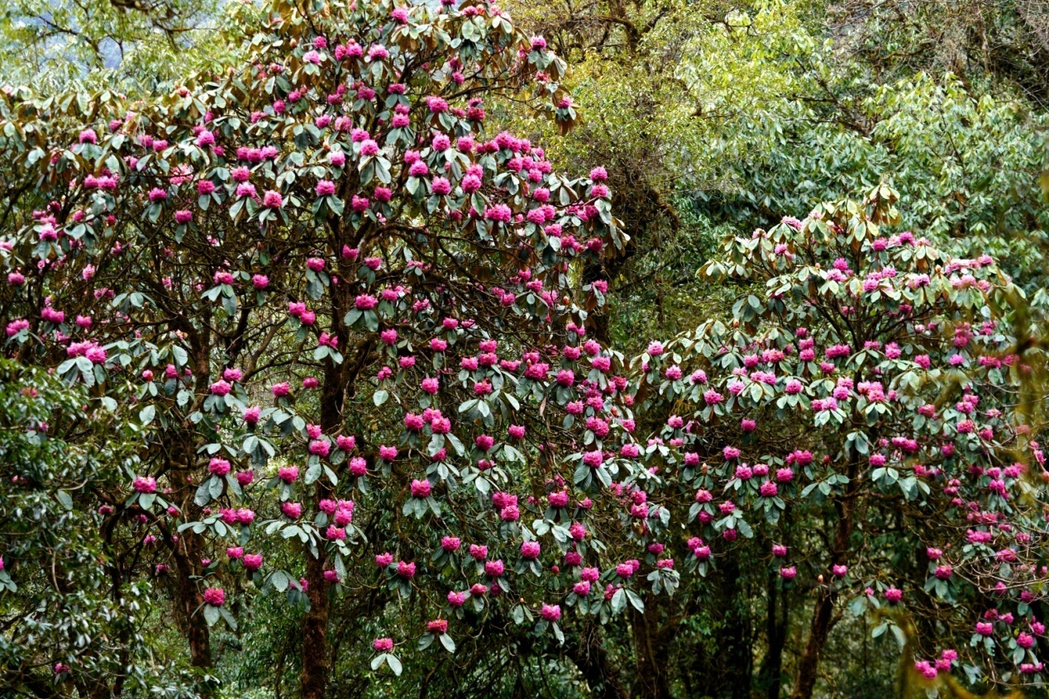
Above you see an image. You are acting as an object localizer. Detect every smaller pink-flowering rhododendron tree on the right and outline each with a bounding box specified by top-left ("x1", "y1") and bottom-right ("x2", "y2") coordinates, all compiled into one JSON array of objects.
[{"x1": 635, "y1": 186, "x2": 1049, "y2": 697}]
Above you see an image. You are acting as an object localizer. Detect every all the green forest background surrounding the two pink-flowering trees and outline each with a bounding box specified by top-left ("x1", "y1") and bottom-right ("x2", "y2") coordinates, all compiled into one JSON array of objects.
[{"x1": 0, "y1": 0, "x2": 1049, "y2": 699}]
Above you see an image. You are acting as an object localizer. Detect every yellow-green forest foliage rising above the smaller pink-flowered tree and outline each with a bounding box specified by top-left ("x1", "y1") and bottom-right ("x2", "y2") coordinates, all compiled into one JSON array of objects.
[{"x1": 503, "y1": 0, "x2": 1047, "y2": 350}]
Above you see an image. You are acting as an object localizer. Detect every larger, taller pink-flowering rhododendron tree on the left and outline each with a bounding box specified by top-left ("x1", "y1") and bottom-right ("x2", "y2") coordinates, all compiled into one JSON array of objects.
[{"x1": 3, "y1": 1, "x2": 671, "y2": 697}]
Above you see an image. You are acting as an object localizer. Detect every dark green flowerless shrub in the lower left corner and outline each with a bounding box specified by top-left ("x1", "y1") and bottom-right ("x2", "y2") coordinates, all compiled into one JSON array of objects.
[{"x1": 0, "y1": 359, "x2": 205, "y2": 697}]
